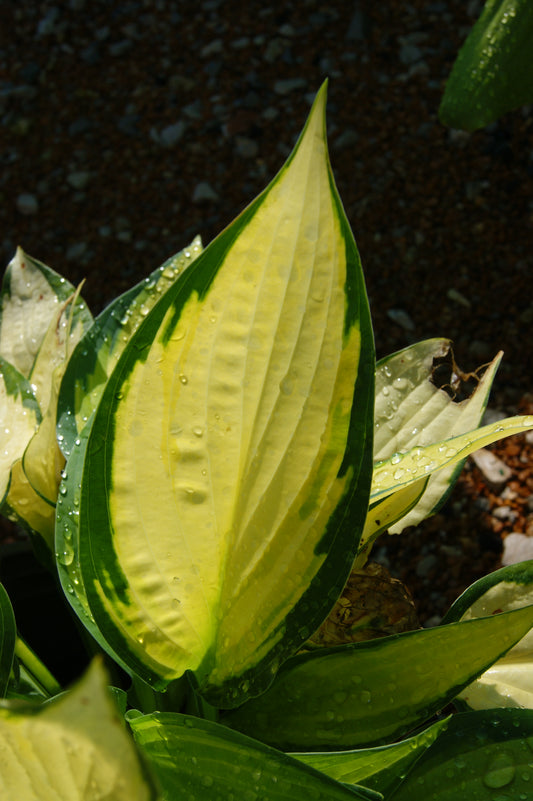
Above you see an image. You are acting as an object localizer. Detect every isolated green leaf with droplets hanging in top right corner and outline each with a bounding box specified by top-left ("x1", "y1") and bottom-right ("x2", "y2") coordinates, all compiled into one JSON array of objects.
[{"x1": 439, "y1": 0, "x2": 533, "y2": 131}]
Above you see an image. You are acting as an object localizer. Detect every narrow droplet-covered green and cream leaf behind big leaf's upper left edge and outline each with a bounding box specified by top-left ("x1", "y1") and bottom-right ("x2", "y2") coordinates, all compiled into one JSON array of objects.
[{"x1": 57, "y1": 237, "x2": 202, "y2": 456}]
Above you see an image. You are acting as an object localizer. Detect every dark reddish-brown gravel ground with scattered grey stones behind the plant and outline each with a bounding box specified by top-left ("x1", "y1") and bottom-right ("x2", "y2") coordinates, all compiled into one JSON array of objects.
[{"x1": 0, "y1": 0, "x2": 533, "y2": 620}]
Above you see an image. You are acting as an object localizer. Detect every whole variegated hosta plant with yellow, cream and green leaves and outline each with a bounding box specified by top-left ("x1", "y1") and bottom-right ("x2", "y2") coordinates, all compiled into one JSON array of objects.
[{"x1": 0, "y1": 87, "x2": 533, "y2": 801}]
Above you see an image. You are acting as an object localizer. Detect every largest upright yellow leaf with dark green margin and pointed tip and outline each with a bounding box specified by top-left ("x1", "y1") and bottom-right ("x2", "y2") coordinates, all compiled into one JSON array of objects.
[{"x1": 63, "y1": 84, "x2": 375, "y2": 705}]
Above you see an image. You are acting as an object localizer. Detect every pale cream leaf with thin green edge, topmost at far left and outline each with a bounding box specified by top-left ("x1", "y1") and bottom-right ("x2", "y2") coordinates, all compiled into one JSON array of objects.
[{"x1": 0, "y1": 248, "x2": 92, "y2": 378}]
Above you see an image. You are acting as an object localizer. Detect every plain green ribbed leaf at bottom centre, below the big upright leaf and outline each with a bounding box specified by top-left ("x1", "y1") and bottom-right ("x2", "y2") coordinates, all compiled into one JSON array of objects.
[{"x1": 128, "y1": 712, "x2": 368, "y2": 801}]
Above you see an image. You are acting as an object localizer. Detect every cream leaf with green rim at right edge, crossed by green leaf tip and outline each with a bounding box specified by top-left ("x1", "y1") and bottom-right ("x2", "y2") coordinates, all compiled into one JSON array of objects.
[{"x1": 443, "y1": 560, "x2": 533, "y2": 709}]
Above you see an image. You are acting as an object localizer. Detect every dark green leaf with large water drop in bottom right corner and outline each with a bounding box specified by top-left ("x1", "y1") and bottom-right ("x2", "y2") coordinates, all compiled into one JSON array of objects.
[{"x1": 388, "y1": 709, "x2": 533, "y2": 801}]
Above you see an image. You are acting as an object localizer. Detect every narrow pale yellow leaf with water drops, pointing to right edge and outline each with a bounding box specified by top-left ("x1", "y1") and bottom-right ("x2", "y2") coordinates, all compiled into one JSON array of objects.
[{"x1": 370, "y1": 415, "x2": 533, "y2": 501}]
